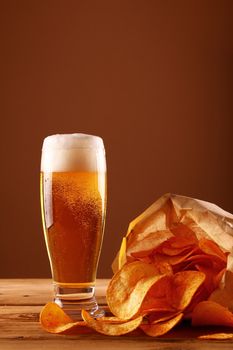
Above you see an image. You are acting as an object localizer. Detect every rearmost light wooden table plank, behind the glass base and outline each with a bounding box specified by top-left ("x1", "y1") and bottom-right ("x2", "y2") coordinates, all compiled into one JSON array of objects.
[{"x1": 0, "y1": 279, "x2": 109, "y2": 305}]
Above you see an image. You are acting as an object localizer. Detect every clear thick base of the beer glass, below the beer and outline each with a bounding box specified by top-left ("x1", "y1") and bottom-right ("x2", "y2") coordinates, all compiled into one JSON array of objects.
[{"x1": 54, "y1": 283, "x2": 105, "y2": 321}]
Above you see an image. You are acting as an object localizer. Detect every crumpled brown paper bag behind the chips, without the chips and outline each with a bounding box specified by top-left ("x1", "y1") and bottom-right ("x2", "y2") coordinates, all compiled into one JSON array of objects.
[{"x1": 112, "y1": 193, "x2": 233, "y2": 311}]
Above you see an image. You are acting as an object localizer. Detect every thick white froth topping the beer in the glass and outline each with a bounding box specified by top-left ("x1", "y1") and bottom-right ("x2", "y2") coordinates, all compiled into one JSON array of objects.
[{"x1": 41, "y1": 134, "x2": 106, "y2": 172}]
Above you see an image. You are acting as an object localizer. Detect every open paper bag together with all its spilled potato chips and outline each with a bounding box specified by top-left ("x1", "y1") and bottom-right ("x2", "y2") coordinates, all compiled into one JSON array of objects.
[{"x1": 40, "y1": 195, "x2": 233, "y2": 339}]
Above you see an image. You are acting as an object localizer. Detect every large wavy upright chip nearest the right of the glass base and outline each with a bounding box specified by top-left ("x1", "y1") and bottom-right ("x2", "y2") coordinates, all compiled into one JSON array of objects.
[{"x1": 106, "y1": 261, "x2": 167, "y2": 320}]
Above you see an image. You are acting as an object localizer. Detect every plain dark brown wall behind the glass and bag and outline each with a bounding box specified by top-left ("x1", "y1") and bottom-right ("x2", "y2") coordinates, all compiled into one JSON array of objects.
[{"x1": 0, "y1": 0, "x2": 233, "y2": 277}]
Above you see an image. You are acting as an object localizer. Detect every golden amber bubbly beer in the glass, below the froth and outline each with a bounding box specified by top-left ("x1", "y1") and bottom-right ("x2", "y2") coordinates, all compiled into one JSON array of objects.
[{"x1": 41, "y1": 172, "x2": 105, "y2": 285}]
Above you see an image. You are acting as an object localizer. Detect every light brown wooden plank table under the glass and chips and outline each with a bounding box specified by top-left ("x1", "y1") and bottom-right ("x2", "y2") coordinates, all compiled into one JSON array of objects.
[{"x1": 0, "y1": 279, "x2": 233, "y2": 350}]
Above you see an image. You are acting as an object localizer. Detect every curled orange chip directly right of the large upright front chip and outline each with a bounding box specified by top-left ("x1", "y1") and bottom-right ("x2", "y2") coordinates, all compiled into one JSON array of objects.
[{"x1": 167, "y1": 271, "x2": 205, "y2": 310}]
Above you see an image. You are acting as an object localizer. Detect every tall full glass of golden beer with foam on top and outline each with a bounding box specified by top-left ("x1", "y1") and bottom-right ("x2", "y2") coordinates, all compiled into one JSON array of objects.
[{"x1": 40, "y1": 134, "x2": 106, "y2": 320}]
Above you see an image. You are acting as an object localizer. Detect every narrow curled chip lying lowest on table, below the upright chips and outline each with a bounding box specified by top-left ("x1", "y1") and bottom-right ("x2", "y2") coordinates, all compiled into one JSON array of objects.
[{"x1": 140, "y1": 313, "x2": 183, "y2": 337}]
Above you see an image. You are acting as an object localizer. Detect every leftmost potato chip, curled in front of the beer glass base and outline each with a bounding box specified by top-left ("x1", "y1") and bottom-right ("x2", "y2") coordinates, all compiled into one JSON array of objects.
[{"x1": 40, "y1": 303, "x2": 90, "y2": 334}]
